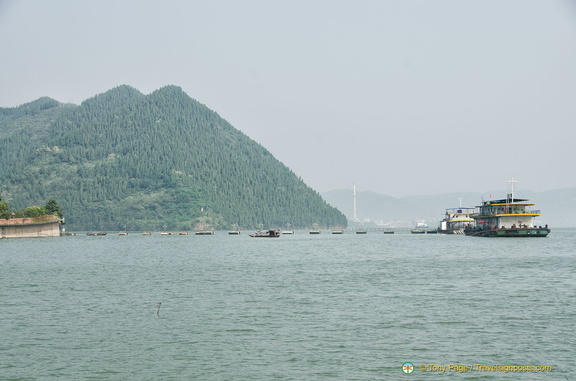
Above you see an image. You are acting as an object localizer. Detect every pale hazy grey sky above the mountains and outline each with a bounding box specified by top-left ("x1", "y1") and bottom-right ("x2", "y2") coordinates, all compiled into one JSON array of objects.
[{"x1": 0, "y1": 0, "x2": 576, "y2": 196}]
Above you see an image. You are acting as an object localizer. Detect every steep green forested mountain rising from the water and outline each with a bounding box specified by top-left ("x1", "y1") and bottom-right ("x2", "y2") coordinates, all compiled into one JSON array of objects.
[{"x1": 0, "y1": 86, "x2": 346, "y2": 230}]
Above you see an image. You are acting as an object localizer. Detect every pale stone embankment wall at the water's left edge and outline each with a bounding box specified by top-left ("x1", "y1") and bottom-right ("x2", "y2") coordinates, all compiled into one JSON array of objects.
[{"x1": 0, "y1": 216, "x2": 61, "y2": 238}]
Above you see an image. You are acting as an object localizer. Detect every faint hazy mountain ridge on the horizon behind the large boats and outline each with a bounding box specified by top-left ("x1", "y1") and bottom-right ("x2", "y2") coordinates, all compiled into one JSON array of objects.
[{"x1": 322, "y1": 188, "x2": 576, "y2": 228}]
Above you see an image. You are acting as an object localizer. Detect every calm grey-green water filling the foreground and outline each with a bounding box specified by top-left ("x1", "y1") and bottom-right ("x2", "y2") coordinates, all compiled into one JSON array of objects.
[{"x1": 0, "y1": 229, "x2": 576, "y2": 380}]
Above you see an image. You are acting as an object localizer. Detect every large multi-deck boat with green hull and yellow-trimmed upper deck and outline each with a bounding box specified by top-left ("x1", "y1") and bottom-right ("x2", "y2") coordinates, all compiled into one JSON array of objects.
[{"x1": 464, "y1": 179, "x2": 550, "y2": 238}]
